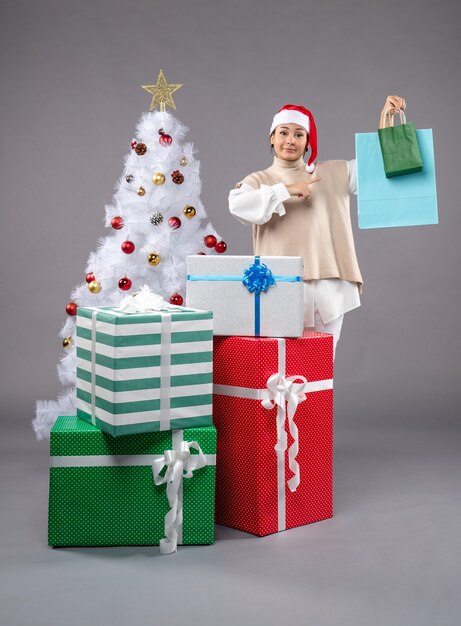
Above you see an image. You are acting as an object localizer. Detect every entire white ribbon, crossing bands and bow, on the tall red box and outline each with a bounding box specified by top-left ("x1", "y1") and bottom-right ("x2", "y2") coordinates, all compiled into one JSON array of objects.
[{"x1": 213, "y1": 337, "x2": 333, "y2": 531}]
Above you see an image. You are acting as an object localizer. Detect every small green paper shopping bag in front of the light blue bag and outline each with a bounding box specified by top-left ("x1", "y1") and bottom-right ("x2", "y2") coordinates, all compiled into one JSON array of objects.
[{"x1": 378, "y1": 110, "x2": 423, "y2": 178}]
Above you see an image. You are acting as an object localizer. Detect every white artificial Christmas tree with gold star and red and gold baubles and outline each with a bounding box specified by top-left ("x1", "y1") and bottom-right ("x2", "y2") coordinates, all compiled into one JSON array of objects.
[{"x1": 33, "y1": 70, "x2": 226, "y2": 439}]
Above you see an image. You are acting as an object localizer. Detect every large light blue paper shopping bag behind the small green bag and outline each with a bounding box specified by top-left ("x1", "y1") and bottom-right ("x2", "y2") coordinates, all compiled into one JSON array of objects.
[{"x1": 355, "y1": 129, "x2": 438, "y2": 228}]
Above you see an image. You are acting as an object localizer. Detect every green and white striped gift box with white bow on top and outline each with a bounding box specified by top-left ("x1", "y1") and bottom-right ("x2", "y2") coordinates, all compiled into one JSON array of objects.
[{"x1": 76, "y1": 307, "x2": 213, "y2": 435}]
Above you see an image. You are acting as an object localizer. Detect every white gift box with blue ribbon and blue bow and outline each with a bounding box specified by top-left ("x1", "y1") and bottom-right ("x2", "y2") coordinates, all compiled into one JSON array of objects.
[{"x1": 186, "y1": 255, "x2": 304, "y2": 337}]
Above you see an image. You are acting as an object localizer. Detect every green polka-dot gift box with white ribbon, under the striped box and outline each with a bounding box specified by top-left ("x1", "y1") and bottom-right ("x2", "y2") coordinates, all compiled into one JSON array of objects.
[{"x1": 48, "y1": 417, "x2": 216, "y2": 552}]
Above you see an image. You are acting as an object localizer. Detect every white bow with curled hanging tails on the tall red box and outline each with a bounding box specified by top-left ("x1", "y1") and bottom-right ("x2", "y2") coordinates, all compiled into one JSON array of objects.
[{"x1": 261, "y1": 374, "x2": 307, "y2": 491}]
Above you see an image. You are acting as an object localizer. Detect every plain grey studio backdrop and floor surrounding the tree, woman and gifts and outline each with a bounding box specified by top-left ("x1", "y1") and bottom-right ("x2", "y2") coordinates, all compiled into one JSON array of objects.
[{"x1": 0, "y1": 0, "x2": 461, "y2": 626}]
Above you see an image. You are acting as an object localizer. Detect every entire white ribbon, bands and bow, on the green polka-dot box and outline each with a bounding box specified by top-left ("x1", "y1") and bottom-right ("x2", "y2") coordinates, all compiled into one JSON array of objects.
[{"x1": 50, "y1": 430, "x2": 216, "y2": 554}]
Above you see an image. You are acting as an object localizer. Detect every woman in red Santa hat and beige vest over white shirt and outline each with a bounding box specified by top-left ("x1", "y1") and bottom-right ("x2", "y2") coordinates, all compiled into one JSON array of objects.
[{"x1": 229, "y1": 96, "x2": 406, "y2": 349}]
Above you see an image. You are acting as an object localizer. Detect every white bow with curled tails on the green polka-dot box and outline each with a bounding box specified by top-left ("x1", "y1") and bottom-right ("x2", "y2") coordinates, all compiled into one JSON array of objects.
[{"x1": 152, "y1": 441, "x2": 207, "y2": 554}]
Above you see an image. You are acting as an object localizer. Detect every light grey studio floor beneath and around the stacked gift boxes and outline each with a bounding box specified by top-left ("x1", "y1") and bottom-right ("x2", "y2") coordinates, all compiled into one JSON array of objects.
[{"x1": 0, "y1": 410, "x2": 461, "y2": 626}]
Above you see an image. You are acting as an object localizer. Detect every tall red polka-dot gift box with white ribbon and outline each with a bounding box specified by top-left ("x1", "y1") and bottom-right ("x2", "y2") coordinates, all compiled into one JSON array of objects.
[{"x1": 213, "y1": 332, "x2": 333, "y2": 536}]
